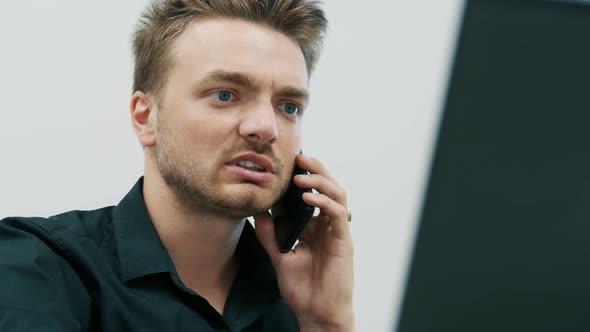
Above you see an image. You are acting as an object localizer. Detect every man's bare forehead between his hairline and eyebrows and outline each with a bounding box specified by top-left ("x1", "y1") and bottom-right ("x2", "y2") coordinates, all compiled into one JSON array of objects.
[{"x1": 172, "y1": 19, "x2": 308, "y2": 87}]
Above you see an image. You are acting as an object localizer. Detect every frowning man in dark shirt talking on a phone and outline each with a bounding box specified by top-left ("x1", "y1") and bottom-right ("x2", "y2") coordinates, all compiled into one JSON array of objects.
[{"x1": 0, "y1": 0, "x2": 354, "y2": 331}]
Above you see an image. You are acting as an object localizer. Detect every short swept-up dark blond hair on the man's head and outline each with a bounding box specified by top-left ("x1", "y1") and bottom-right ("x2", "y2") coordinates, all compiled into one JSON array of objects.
[{"x1": 132, "y1": 0, "x2": 327, "y2": 98}]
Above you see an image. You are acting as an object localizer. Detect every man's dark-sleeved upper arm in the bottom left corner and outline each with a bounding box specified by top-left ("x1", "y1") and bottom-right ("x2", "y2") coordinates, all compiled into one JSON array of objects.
[{"x1": 0, "y1": 218, "x2": 90, "y2": 332}]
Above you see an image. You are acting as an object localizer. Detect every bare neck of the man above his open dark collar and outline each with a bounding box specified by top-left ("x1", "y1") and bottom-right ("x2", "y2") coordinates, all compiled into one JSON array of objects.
[{"x1": 143, "y1": 158, "x2": 245, "y2": 300}]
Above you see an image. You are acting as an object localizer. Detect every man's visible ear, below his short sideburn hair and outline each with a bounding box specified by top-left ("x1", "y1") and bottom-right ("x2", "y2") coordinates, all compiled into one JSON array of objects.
[{"x1": 130, "y1": 91, "x2": 157, "y2": 148}]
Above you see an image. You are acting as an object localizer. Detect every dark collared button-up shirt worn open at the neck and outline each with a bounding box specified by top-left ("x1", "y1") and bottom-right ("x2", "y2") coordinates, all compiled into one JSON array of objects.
[{"x1": 0, "y1": 178, "x2": 299, "y2": 332}]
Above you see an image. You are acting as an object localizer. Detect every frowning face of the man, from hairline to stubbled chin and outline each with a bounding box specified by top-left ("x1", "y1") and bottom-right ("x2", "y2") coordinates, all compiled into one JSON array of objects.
[{"x1": 155, "y1": 19, "x2": 308, "y2": 218}]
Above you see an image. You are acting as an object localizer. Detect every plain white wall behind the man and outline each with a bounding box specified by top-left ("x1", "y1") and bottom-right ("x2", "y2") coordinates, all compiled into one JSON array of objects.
[{"x1": 0, "y1": 0, "x2": 463, "y2": 331}]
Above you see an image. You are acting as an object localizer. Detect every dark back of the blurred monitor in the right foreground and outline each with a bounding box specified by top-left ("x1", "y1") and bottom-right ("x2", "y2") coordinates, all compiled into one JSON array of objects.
[{"x1": 396, "y1": 0, "x2": 590, "y2": 332}]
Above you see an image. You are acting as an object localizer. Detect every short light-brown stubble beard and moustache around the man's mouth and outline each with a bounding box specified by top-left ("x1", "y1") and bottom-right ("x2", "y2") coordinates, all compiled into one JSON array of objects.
[{"x1": 155, "y1": 111, "x2": 291, "y2": 219}]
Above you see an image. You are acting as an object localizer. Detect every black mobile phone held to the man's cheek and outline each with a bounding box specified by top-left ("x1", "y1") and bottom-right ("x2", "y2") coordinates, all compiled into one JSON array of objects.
[{"x1": 270, "y1": 152, "x2": 315, "y2": 254}]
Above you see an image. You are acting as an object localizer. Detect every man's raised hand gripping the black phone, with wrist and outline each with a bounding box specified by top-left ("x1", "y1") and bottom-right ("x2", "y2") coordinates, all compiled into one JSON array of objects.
[{"x1": 254, "y1": 155, "x2": 354, "y2": 331}]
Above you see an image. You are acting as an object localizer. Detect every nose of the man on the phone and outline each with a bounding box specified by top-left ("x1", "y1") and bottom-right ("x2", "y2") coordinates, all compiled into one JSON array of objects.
[{"x1": 239, "y1": 102, "x2": 279, "y2": 144}]
